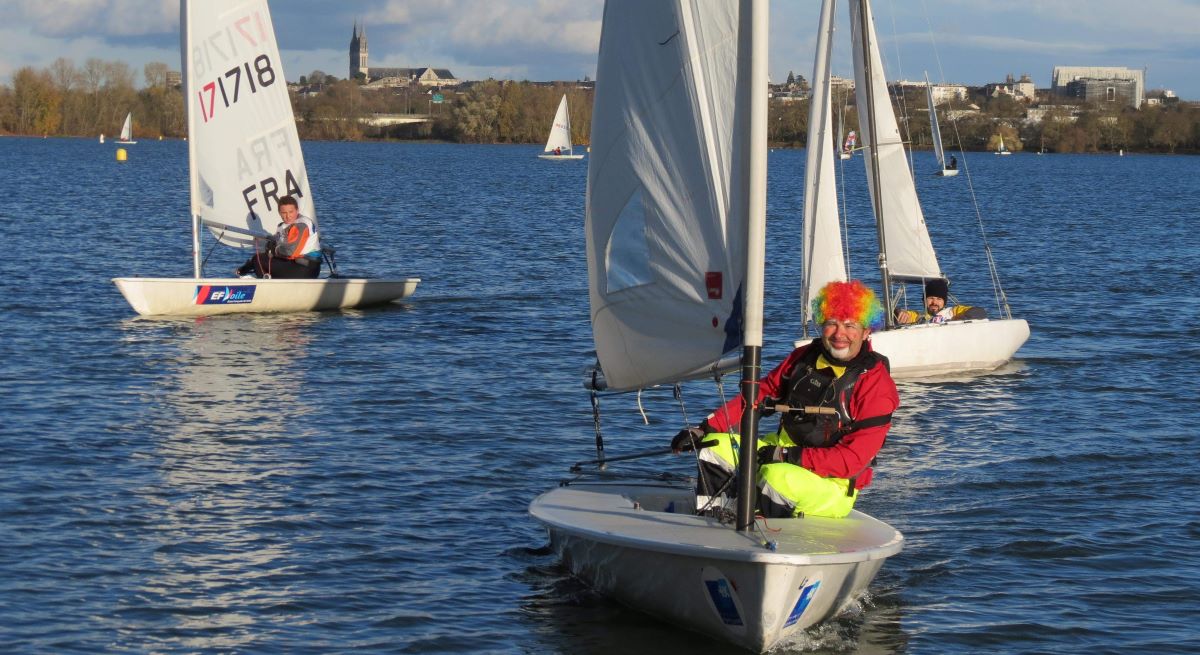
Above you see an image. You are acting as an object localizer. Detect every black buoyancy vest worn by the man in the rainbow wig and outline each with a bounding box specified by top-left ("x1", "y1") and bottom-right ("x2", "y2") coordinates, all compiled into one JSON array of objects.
[{"x1": 779, "y1": 339, "x2": 892, "y2": 447}]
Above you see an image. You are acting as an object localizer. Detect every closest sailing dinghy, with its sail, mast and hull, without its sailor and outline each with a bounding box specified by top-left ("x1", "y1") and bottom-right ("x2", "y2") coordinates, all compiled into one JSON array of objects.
[{"x1": 529, "y1": 0, "x2": 904, "y2": 653}]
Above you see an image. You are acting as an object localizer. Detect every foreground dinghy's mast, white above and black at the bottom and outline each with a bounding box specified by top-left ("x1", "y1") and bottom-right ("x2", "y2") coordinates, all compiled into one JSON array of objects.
[{"x1": 734, "y1": 0, "x2": 768, "y2": 531}]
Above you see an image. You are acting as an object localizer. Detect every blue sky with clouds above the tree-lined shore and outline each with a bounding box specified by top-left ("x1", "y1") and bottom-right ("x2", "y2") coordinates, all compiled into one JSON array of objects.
[{"x1": 0, "y1": 0, "x2": 1200, "y2": 100}]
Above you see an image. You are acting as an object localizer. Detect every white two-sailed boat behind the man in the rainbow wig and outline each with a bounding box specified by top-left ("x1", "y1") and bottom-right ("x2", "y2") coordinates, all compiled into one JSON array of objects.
[{"x1": 802, "y1": 0, "x2": 1030, "y2": 378}]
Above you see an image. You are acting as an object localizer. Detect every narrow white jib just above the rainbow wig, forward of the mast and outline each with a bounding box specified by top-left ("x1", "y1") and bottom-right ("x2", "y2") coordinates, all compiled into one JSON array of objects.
[{"x1": 800, "y1": 0, "x2": 846, "y2": 325}]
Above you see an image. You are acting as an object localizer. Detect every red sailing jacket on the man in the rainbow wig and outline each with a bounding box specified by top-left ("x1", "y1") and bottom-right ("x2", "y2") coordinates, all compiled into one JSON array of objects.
[{"x1": 706, "y1": 339, "x2": 900, "y2": 489}]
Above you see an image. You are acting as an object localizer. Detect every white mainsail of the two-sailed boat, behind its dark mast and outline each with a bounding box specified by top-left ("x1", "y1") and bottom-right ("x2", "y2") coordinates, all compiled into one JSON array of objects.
[{"x1": 850, "y1": 0, "x2": 942, "y2": 278}]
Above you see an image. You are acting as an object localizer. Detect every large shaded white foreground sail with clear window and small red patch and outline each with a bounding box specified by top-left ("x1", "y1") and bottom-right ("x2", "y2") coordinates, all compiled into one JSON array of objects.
[{"x1": 586, "y1": 0, "x2": 749, "y2": 389}]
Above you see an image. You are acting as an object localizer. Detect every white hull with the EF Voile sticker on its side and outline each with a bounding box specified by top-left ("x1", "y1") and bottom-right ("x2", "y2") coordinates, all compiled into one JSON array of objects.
[{"x1": 113, "y1": 277, "x2": 421, "y2": 316}]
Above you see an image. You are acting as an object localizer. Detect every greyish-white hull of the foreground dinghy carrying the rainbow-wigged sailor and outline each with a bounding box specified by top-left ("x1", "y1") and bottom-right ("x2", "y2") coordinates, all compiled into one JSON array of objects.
[{"x1": 529, "y1": 483, "x2": 904, "y2": 653}]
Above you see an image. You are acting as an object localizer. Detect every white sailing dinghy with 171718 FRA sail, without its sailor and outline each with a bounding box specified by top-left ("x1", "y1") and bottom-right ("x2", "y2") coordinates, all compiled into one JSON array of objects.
[{"x1": 113, "y1": 0, "x2": 420, "y2": 316}]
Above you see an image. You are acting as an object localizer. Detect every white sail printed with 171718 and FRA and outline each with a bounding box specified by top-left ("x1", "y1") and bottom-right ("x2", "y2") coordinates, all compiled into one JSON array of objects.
[{"x1": 180, "y1": 0, "x2": 317, "y2": 247}]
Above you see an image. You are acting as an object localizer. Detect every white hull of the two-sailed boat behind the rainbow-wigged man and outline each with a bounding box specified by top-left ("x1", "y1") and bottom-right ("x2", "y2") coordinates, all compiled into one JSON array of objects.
[{"x1": 871, "y1": 318, "x2": 1030, "y2": 378}]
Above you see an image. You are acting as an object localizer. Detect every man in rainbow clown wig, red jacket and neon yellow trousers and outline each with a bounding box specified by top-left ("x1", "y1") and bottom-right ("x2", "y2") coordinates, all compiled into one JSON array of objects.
[{"x1": 671, "y1": 280, "x2": 900, "y2": 518}]
